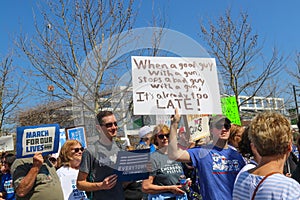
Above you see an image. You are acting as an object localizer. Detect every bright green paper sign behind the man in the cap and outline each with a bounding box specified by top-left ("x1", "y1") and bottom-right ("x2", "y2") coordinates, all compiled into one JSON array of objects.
[{"x1": 221, "y1": 96, "x2": 241, "y2": 125}]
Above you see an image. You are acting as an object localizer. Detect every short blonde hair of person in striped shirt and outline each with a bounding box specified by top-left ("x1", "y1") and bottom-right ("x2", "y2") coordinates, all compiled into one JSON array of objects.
[{"x1": 249, "y1": 112, "x2": 293, "y2": 156}]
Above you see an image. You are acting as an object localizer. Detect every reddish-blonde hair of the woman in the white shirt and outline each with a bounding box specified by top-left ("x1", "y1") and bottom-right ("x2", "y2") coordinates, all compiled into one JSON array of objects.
[{"x1": 57, "y1": 140, "x2": 82, "y2": 167}]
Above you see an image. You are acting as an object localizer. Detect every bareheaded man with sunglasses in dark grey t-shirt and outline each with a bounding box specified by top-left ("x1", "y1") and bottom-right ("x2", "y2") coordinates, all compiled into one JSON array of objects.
[{"x1": 77, "y1": 111, "x2": 125, "y2": 200}]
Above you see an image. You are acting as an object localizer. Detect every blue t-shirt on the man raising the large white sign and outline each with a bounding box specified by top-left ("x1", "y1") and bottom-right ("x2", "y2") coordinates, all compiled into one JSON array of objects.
[{"x1": 187, "y1": 145, "x2": 245, "y2": 200}]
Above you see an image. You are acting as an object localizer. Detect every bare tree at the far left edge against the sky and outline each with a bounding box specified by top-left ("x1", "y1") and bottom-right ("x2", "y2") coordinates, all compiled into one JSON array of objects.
[{"x1": 0, "y1": 54, "x2": 26, "y2": 135}]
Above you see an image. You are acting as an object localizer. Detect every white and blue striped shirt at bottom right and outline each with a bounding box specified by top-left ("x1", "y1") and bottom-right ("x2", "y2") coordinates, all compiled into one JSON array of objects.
[{"x1": 233, "y1": 171, "x2": 300, "y2": 200}]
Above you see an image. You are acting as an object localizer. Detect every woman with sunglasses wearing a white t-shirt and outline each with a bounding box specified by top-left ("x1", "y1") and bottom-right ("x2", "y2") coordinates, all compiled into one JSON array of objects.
[{"x1": 57, "y1": 140, "x2": 87, "y2": 200}]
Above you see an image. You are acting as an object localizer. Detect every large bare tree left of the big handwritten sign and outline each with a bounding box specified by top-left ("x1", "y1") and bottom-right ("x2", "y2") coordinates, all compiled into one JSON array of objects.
[{"x1": 17, "y1": 0, "x2": 135, "y2": 136}]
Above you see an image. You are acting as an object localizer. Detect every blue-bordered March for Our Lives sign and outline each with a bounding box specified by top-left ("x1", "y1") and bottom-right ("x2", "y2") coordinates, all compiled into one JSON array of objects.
[{"x1": 17, "y1": 124, "x2": 59, "y2": 158}]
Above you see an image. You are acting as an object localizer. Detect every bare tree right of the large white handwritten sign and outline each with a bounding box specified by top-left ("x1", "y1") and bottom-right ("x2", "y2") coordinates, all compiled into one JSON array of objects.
[{"x1": 200, "y1": 9, "x2": 286, "y2": 107}]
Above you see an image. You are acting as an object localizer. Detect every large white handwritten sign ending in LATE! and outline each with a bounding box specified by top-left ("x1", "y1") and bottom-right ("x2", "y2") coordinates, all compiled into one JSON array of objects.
[{"x1": 131, "y1": 56, "x2": 222, "y2": 115}]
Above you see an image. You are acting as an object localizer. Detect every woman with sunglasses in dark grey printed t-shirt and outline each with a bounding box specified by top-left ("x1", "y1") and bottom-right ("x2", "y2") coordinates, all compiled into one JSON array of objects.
[{"x1": 142, "y1": 124, "x2": 187, "y2": 200}]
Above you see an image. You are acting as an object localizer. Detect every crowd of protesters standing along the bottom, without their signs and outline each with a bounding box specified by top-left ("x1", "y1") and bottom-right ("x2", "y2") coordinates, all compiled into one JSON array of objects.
[{"x1": 0, "y1": 109, "x2": 300, "y2": 200}]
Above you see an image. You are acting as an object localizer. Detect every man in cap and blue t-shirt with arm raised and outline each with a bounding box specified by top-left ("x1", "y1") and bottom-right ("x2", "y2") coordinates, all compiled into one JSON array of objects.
[{"x1": 168, "y1": 109, "x2": 245, "y2": 200}]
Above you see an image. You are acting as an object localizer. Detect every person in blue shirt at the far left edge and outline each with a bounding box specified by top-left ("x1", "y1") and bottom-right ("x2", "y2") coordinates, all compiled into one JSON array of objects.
[{"x1": 0, "y1": 153, "x2": 16, "y2": 200}]
